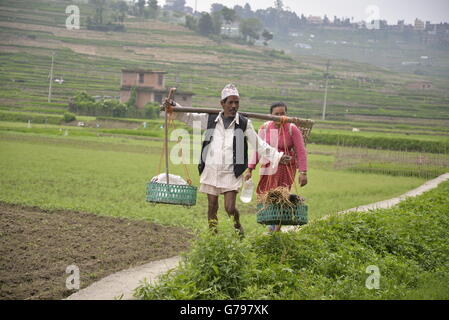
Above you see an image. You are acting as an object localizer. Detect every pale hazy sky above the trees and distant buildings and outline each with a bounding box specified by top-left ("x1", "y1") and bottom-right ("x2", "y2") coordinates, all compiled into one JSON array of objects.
[{"x1": 174, "y1": 0, "x2": 449, "y2": 24}]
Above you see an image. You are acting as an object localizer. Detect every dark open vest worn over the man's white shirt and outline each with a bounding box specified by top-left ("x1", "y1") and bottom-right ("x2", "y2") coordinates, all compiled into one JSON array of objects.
[{"x1": 198, "y1": 114, "x2": 248, "y2": 178}]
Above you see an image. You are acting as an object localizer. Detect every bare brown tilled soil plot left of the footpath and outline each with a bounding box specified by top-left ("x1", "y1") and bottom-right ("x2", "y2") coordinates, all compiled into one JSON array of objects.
[{"x1": 0, "y1": 202, "x2": 193, "y2": 299}]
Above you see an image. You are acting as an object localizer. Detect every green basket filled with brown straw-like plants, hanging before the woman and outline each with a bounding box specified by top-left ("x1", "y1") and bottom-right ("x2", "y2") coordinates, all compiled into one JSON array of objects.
[{"x1": 257, "y1": 203, "x2": 308, "y2": 226}]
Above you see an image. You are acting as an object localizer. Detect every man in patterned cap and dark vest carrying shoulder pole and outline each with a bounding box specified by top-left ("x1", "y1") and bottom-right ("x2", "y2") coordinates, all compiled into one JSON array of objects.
[{"x1": 164, "y1": 84, "x2": 291, "y2": 237}]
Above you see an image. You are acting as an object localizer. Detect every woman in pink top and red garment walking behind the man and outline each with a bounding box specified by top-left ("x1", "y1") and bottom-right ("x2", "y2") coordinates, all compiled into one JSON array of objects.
[{"x1": 245, "y1": 102, "x2": 307, "y2": 231}]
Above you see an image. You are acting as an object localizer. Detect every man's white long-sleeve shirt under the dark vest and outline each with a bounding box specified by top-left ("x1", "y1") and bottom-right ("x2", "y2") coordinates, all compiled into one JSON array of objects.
[{"x1": 166, "y1": 104, "x2": 284, "y2": 190}]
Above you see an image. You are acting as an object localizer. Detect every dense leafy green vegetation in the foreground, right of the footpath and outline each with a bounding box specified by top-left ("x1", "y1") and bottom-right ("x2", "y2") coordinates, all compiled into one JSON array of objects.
[{"x1": 135, "y1": 182, "x2": 449, "y2": 300}]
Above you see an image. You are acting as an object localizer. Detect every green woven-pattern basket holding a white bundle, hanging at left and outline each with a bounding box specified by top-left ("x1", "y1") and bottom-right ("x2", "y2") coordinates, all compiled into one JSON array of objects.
[{"x1": 147, "y1": 182, "x2": 197, "y2": 206}]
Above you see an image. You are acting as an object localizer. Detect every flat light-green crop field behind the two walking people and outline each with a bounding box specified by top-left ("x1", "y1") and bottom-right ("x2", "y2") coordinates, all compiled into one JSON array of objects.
[{"x1": 0, "y1": 124, "x2": 425, "y2": 229}]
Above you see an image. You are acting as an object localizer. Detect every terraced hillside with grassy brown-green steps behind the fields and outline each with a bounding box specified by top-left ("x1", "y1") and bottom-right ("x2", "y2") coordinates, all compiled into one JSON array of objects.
[{"x1": 0, "y1": 0, "x2": 449, "y2": 128}]
